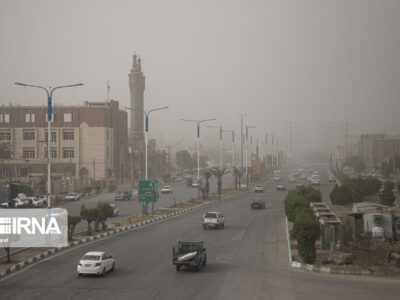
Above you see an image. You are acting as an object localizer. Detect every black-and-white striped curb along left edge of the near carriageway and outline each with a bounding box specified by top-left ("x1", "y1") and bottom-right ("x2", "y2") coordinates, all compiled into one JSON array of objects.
[{"x1": 0, "y1": 200, "x2": 217, "y2": 279}]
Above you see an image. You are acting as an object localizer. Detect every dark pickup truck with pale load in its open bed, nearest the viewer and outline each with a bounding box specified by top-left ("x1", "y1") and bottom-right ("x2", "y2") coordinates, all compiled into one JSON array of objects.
[{"x1": 172, "y1": 241, "x2": 207, "y2": 271}]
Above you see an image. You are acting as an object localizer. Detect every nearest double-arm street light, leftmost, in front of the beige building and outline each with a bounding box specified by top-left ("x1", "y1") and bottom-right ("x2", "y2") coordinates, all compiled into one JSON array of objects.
[{"x1": 15, "y1": 82, "x2": 83, "y2": 209}]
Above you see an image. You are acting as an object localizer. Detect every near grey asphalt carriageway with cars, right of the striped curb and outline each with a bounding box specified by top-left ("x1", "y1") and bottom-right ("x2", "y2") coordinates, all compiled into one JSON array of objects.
[{"x1": 0, "y1": 168, "x2": 400, "y2": 300}]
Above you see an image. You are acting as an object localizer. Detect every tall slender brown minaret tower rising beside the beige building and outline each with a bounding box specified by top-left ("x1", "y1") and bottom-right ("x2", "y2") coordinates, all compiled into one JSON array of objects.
[{"x1": 128, "y1": 54, "x2": 146, "y2": 146}]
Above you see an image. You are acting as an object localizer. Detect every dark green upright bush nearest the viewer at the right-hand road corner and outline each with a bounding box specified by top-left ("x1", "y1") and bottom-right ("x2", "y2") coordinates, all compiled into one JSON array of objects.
[{"x1": 292, "y1": 210, "x2": 321, "y2": 264}]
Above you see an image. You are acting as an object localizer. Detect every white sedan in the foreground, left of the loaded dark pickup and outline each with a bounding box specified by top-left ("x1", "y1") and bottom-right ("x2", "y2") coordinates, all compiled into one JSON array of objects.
[{"x1": 77, "y1": 252, "x2": 115, "y2": 276}]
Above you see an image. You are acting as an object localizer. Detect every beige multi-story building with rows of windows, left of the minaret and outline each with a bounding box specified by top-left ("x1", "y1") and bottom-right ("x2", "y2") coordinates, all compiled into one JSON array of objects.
[{"x1": 0, "y1": 100, "x2": 129, "y2": 191}]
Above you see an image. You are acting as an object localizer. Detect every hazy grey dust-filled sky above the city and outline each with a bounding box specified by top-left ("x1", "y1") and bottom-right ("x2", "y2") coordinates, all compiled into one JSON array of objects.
[{"x1": 0, "y1": 0, "x2": 400, "y2": 150}]
